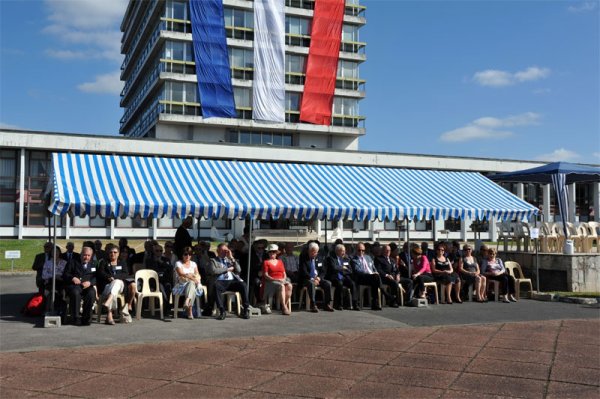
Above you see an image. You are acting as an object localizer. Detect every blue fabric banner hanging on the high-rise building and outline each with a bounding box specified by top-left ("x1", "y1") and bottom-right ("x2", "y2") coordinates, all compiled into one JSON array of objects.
[{"x1": 190, "y1": 0, "x2": 237, "y2": 118}]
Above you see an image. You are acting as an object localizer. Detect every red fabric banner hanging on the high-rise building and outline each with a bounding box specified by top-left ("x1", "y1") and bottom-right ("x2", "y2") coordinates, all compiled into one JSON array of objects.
[{"x1": 300, "y1": 0, "x2": 345, "y2": 126}]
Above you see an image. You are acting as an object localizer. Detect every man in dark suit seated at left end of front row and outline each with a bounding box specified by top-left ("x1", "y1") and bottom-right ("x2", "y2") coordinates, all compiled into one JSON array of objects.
[{"x1": 63, "y1": 247, "x2": 97, "y2": 326}]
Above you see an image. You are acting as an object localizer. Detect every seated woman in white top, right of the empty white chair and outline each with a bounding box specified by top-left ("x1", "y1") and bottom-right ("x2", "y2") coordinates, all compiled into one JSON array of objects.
[{"x1": 173, "y1": 247, "x2": 204, "y2": 319}]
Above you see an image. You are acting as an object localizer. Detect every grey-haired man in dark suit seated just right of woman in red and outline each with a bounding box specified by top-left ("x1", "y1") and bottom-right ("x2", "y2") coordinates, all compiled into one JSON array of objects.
[{"x1": 298, "y1": 241, "x2": 333, "y2": 313}]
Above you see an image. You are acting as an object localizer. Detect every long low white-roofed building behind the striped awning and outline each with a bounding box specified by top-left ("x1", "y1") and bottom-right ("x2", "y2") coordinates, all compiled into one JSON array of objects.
[{"x1": 0, "y1": 130, "x2": 600, "y2": 241}]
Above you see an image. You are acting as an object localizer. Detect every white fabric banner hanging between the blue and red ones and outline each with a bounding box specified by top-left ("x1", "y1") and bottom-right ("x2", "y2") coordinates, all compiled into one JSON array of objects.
[{"x1": 252, "y1": 0, "x2": 285, "y2": 122}]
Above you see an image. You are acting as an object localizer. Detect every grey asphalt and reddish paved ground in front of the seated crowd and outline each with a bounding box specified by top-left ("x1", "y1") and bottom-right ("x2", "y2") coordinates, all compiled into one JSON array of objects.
[{"x1": 0, "y1": 276, "x2": 600, "y2": 399}]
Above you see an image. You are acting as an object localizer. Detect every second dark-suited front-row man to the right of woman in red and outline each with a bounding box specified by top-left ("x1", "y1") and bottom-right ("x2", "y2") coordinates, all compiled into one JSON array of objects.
[{"x1": 325, "y1": 244, "x2": 360, "y2": 310}]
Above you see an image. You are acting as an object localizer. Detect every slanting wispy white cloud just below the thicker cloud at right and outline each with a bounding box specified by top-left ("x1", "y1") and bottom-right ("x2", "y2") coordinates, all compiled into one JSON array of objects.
[{"x1": 440, "y1": 112, "x2": 541, "y2": 142}]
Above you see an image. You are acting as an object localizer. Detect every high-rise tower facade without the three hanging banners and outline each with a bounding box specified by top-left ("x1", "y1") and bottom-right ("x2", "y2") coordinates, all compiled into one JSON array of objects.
[{"x1": 120, "y1": 0, "x2": 366, "y2": 150}]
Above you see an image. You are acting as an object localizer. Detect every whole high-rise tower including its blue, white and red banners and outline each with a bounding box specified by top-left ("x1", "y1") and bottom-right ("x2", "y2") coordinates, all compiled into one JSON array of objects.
[{"x1": 120, "y1": 0, "x2": 366, "y2": 149}]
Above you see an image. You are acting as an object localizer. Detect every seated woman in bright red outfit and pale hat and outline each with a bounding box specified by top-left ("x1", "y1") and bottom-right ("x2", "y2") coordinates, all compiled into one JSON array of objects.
[{"x1": 262, "y1": 244, "x2": 292, "y2": 315}]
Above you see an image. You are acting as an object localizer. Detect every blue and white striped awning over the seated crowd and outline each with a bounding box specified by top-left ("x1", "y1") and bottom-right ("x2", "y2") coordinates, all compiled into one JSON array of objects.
[{"x1": 49, "y1": 153, "x2": 537, "y2": 221}]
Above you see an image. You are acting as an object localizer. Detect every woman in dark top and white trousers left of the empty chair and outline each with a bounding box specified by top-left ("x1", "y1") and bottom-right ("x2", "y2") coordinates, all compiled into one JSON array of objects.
[{"x1": 96, "y1": 244, "x2": 136, "y2": 326}]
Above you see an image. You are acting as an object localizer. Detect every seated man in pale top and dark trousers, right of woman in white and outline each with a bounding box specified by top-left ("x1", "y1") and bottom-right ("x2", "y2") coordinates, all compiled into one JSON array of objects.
[{"x1": 211, "y1": 243, "x2": 250, "y2": 320}]
